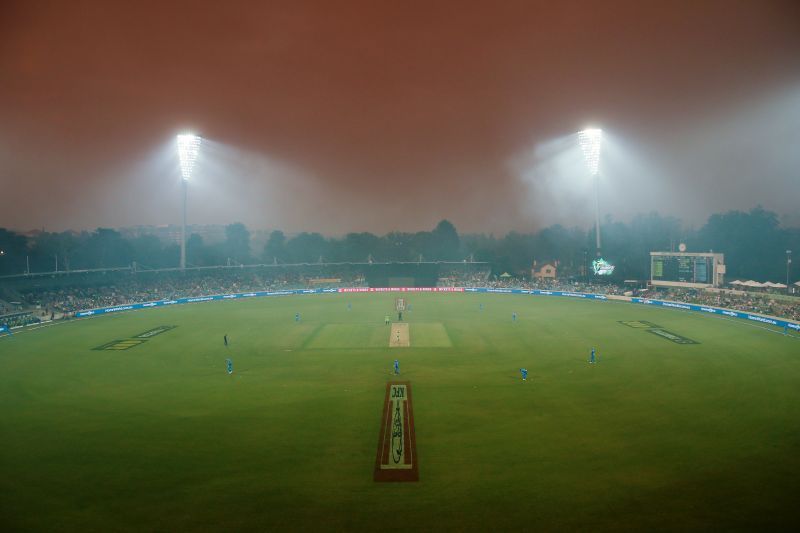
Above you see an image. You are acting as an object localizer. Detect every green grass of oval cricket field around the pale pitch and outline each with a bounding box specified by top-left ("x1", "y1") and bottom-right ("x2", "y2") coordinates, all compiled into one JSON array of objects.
[{"x1": 0, "y1": 294, "x2": 800, "y2": 531}]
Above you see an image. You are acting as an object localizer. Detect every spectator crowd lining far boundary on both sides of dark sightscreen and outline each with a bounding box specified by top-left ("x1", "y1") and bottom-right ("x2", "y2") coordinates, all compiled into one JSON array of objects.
[{"x1": 5, "y1": 269, "x2": 800, "y2": 326}]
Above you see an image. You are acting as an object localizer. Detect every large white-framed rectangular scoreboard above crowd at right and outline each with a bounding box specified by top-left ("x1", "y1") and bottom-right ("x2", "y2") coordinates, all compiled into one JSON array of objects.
[{"x1": 650, "y1": 252, "x2": 725, "y2": 287}]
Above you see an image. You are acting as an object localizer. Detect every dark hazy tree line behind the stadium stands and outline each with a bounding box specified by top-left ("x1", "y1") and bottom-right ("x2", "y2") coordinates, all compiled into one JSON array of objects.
[{"x1": 0, "y1": 207, "x2": 800, "y2": 281}]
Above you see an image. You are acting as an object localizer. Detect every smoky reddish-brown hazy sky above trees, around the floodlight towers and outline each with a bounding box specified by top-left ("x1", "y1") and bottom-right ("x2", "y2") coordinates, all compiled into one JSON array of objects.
[{"x1": 0, "y1": 0, "x2": 800, "y2": 234}]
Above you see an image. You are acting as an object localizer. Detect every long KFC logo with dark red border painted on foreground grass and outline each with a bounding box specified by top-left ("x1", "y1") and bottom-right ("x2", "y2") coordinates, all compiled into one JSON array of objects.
[{"x1": 373, "y1": 381, "x2": 419, "y2": 481}]
